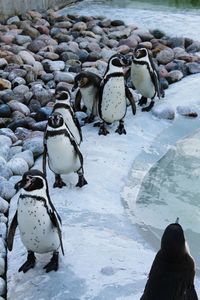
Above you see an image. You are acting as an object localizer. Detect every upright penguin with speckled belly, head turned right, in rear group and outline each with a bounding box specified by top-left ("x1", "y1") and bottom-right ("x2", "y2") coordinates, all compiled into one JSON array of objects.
[{"x1": 98, "y1": 54, "x2": 136, "y2": 135}]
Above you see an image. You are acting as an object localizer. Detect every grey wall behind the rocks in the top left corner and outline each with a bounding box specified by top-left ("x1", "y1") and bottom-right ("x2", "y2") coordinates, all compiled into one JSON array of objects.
[{"x1": 0, "y1": 0, "x2": 79, "y2": 20}]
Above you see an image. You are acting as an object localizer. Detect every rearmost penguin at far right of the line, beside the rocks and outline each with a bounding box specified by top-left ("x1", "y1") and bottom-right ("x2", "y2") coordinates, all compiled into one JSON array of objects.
[{"x1": 131, "y1": 45, "x2": 164, "y2": 111}]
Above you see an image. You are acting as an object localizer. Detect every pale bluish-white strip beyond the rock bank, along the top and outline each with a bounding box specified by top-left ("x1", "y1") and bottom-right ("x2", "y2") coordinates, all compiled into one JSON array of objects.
[{"x1": 60, "y1": 0, "x2": 200, "y2": 40}]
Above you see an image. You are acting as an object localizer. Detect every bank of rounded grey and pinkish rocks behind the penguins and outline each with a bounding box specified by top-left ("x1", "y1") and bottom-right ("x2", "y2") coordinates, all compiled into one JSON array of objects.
[{"x1": 0, "y1": 10, "x2": 200, "y2": 297}]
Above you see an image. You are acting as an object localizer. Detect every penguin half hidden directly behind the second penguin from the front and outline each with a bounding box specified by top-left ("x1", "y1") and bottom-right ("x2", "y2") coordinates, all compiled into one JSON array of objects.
[{"x1": 52, "y1": 87, "x2": 82, "y2": 145}]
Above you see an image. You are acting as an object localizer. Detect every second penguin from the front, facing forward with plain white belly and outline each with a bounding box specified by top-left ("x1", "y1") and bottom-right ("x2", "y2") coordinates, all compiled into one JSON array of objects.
[{"x1": 43, "y1": 112, "x2": 87, "y2": 188}]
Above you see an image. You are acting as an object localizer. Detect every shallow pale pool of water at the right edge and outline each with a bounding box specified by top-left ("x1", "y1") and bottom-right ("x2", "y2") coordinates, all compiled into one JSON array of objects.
[{"x1": 135, "y1": 130, "x2": 200, "y2": 268}]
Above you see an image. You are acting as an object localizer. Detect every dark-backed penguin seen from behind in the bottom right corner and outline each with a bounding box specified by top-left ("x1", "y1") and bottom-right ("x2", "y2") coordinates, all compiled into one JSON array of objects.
[{"x1": 140, "y1": 221, "x2": 198, "y2": 300}]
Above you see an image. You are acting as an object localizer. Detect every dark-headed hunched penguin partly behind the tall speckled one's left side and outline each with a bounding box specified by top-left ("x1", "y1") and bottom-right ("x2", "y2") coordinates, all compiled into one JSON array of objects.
[{"x1": 72, "y1": 71, "x2": 102, "y2": 123}]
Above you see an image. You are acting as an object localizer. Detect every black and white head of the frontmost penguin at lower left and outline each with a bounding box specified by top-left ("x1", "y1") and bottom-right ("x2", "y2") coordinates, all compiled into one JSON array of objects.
[{"x1": 15, "y1": 169, "x2": 45, "y2": 191}]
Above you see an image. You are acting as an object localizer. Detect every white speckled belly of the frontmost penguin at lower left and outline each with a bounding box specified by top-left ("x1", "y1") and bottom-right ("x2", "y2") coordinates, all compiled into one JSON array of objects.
[{"x1": 17, "y1": 197, "x2": 60, "y2": 253}]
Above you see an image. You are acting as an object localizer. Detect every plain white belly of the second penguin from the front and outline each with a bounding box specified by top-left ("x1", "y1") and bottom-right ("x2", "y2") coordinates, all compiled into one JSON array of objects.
[{"x1": 47, "y1": 135, "x2": 81, "y2": 174}]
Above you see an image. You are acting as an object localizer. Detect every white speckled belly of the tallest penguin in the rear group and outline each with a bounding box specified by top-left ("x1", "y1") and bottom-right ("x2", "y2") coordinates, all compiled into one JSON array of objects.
[{"x1": 101, "y1": 76, "x2": 126, "y2": 123}]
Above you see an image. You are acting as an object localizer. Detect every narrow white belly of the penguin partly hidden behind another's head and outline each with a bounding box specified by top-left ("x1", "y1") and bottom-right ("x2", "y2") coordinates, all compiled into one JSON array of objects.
[{"x1": 55, "y1": 108, "x2": 81, "y2": 145}]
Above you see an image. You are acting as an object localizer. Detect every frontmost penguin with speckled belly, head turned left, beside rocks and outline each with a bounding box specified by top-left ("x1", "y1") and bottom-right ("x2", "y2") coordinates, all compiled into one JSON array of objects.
[{"x1": 7, "y1": 170, "x2": 64, "y2": 273}]
